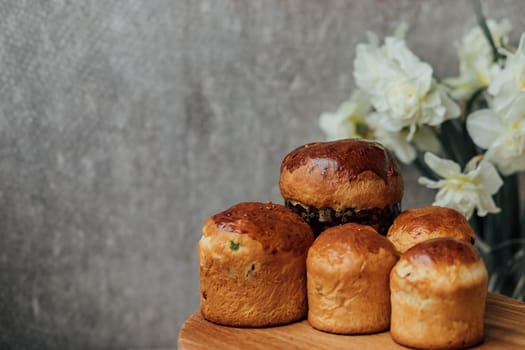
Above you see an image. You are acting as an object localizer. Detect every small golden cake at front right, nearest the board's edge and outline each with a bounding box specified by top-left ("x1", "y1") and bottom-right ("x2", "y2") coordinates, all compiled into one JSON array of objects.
[{"x1": 390, "y1": 238, "x2": 487, "y2": 349}]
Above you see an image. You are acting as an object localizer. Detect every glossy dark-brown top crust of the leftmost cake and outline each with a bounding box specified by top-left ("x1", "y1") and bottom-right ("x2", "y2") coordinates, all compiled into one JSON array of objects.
[{"x1": 202, "y1": 202, "x2": 313, "y2": 254}]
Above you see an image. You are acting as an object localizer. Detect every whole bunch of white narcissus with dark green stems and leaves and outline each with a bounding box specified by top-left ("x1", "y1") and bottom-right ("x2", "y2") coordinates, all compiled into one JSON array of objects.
[{"x1": 319, "y1": 1, "x2": 525, "y2": 300}]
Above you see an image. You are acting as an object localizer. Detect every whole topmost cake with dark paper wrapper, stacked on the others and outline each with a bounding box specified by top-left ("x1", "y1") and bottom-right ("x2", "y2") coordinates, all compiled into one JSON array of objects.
[{"x1": 279, "y1": 139, "x2": 403, "y2": 235}]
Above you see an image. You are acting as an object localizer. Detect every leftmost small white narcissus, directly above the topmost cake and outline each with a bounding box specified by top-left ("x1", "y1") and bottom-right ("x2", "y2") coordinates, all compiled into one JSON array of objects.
[{"x1": 319, "y1": 90, "x2": 371, "y2": 140}]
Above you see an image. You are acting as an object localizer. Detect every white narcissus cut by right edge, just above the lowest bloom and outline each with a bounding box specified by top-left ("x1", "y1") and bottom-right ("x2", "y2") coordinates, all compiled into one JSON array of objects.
[{"x1": 467, "y1": 95, "x2": 525, "y2": 175}]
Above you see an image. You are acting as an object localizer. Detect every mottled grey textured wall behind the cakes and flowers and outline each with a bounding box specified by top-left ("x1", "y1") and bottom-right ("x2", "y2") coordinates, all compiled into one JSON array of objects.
[{"x1": 0, "y1": 0, "x2": 525, "y2": 349}]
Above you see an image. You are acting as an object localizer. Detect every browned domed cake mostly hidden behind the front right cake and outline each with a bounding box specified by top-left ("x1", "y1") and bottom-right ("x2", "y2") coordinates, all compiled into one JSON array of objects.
[{"x1": 386, "y1": 206, "x2": 475, "y2": 253}]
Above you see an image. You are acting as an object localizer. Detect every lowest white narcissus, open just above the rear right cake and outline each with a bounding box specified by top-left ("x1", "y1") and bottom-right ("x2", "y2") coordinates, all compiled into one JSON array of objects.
[{"x1": 418, "y1": 153, "x2": 503, "y2": 219}]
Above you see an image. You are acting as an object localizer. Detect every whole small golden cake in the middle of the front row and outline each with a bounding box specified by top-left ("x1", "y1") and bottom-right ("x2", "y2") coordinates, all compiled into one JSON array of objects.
[{"x1": 306, "y1": 223, "x2": 398, "y2": 334}]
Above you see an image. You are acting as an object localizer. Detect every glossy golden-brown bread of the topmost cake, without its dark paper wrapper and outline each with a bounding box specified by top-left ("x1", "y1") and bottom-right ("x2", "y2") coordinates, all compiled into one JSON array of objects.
[{"x1": 279, "y1": 139, "x2": 403, "y2": 210}]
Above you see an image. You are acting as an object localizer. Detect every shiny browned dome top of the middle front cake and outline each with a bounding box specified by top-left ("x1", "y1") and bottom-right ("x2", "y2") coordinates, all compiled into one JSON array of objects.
[{"x1": 308, "y1": 223, "x2": 398, "y2": 265}]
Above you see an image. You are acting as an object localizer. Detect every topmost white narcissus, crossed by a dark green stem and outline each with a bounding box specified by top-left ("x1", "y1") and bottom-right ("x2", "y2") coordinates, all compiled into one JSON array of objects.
[{"x1": 443, "y1": 20, "x2": 512, "y2": 99}]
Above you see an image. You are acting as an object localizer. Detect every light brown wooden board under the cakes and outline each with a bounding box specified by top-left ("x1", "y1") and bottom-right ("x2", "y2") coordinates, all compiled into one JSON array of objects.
[{"x1": 178, "y1": 293, "x2": 525, "y2": 350}]
